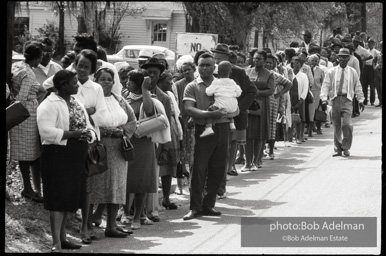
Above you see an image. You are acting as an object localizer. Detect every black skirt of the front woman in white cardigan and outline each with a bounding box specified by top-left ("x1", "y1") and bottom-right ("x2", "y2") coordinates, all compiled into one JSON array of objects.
[{"x1": 41, "y1": 139, "x2": 88, "y2": 212}]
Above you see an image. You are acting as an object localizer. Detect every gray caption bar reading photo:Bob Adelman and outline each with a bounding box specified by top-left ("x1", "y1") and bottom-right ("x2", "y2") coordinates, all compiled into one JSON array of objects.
[{"x1": 241, "y1": 217, "x2": 377, "y2": 247}]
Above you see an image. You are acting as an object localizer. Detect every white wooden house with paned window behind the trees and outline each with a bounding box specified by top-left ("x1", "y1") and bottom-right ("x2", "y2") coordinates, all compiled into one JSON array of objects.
[{"x1": 14, "y1": 1, "x2": 186, "y2": 51}]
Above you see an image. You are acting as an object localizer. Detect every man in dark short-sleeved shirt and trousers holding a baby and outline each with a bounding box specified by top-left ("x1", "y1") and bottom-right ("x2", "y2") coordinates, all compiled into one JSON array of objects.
[{"x1": 183, "y1": 53, "x2": 230, "y2": 220}]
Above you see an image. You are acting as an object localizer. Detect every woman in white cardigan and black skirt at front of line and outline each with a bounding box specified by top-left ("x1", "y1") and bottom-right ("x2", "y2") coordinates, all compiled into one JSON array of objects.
[{"x1": 37, "y1": 70, "x2": 95, "y2": 252}]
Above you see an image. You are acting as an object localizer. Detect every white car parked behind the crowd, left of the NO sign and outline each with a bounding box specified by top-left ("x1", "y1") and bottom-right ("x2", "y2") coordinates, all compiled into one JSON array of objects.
[{"x1": 107, "y1": 45, "x2": 176, "y2": 70}]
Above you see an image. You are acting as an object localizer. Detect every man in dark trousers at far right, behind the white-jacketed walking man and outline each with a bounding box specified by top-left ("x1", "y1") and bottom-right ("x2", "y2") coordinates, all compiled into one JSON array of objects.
[{"x1": 362, "y1": 38, "x2": 379, "y2": 105}]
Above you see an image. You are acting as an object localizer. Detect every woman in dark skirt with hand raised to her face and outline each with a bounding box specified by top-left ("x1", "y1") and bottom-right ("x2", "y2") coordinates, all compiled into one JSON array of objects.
[{"x1": 121, "y1": 70, "x2": 162, "y2": 229}]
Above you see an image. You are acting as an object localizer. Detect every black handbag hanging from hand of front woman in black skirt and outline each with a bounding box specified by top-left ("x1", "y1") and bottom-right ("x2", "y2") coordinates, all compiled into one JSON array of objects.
[{"x1": 86, "y1": 131, "x2": 108, "y2": 177}]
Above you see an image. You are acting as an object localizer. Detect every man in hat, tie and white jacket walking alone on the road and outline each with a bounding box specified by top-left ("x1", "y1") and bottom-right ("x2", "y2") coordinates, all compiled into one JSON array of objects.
[{"x1": 320, "y1": 48, "x2": 365, "y2": 156}]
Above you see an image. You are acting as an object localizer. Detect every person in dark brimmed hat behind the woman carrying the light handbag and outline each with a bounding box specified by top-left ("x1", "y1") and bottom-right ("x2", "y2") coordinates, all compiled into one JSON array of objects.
[{"x1": 140, "y1": 58, "x2": 172, "y2": 222}]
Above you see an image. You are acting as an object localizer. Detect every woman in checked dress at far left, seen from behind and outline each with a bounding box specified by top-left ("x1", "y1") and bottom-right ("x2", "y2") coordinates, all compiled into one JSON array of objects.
[{"x1": 9, "y1": 41, "x2": 43, "y2": 202}]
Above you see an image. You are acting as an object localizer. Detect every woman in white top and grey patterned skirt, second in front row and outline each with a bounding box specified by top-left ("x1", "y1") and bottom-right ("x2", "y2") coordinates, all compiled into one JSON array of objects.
[{"x1": 89, "y1": 68, "x2": 137, "y2": 238}]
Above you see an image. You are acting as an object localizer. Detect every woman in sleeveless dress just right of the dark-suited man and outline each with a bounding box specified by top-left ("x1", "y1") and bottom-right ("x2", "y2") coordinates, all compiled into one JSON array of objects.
[{"x1": 241, "y1": 51, "x2": 275, "y2": 171}]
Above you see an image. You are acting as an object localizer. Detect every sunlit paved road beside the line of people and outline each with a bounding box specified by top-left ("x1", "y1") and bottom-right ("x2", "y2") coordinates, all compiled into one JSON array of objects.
[{"x1": 71, "y1": 106, "x2": 382, "y2": 254}]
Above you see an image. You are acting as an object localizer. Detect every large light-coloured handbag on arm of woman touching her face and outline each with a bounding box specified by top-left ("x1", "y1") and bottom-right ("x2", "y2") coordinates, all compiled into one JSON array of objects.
[{"x1": 134, "y1": 106, "x2": 168, "y2": 138}]
